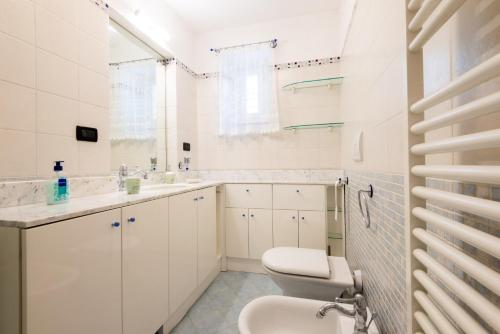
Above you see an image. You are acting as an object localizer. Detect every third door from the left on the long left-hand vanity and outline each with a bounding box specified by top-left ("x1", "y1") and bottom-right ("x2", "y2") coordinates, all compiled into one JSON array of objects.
[{"x1": 168, "y1": 191, "x2": 198, "y2": 314}]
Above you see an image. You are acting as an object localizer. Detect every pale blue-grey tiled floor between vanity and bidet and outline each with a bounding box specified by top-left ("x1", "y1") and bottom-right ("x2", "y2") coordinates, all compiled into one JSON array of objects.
[{"x1": 172, "y1": 271, "x2": 282, "y2": 334}]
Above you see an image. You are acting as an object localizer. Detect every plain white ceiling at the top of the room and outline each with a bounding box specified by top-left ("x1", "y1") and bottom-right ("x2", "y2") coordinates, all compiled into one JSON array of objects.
[{"x1": 163, "y1": 0, "x2": 342, "y2": 32}]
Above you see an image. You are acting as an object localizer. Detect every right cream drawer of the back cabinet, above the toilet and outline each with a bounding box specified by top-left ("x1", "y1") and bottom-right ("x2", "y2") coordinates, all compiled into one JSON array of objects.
[{"x1": 273, "y1": 184, "x2": 326, "y2": 211}]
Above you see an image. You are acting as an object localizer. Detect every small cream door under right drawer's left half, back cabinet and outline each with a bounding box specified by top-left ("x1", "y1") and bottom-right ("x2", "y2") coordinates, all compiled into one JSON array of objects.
[{"x1": 273, "y1": 210, "x2": 299, "y2": 247}]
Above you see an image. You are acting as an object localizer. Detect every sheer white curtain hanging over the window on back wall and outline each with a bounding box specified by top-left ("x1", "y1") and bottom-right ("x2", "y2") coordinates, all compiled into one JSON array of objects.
[{"x1": 219, "y1": 44, "x2": 279, "y2": 136}]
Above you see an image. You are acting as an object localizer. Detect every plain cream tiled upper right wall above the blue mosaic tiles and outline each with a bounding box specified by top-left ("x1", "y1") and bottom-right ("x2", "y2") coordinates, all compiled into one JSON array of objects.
[{"x1": 340, "y1": 0, "x2": 406, "y2": 173}]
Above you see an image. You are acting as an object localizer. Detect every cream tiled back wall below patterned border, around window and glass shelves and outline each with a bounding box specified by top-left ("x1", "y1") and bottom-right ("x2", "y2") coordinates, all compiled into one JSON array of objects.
[{"x1": 197, "y1": 64, "x2": 342, "y2": 170}]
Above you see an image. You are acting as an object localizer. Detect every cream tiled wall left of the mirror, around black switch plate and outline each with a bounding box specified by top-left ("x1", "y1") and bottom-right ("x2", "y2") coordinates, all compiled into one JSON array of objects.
[{"x1": 0, "y1": 0, "x2": 110, "y2": 178}]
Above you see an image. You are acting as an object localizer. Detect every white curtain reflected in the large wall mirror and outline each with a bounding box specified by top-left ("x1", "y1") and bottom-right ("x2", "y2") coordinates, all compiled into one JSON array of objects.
[{"x1": 110, "y1": 60, "x2": 156, "y2": 141}]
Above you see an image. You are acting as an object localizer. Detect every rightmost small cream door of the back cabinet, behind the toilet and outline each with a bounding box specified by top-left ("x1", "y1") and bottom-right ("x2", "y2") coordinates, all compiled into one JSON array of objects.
[{"x1": 299, "y1": 211, "x2": 327, "y2": 249}]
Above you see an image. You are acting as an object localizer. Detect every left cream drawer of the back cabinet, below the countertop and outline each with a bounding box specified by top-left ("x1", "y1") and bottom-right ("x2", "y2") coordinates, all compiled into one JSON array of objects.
[{"x1": 226, "y1": 184, "x2": 273, "y2": 209}]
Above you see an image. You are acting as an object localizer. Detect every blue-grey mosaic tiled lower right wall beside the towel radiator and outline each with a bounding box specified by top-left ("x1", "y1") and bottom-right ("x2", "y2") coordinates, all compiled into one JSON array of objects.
[{"x1": 345, "y1": 170, "x2": 407, "y2": 334}]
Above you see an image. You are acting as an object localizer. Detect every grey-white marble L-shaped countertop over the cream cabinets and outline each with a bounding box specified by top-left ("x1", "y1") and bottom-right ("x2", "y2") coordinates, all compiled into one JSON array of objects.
[{"x1": 0, "y1": 180, "x2": 335, "y2": 228}]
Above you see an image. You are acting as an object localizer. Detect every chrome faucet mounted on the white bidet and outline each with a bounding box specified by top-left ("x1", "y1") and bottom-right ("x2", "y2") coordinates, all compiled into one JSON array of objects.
[{"x1": 316, "y1": 293, "x2": 378, "y2": 334}]
